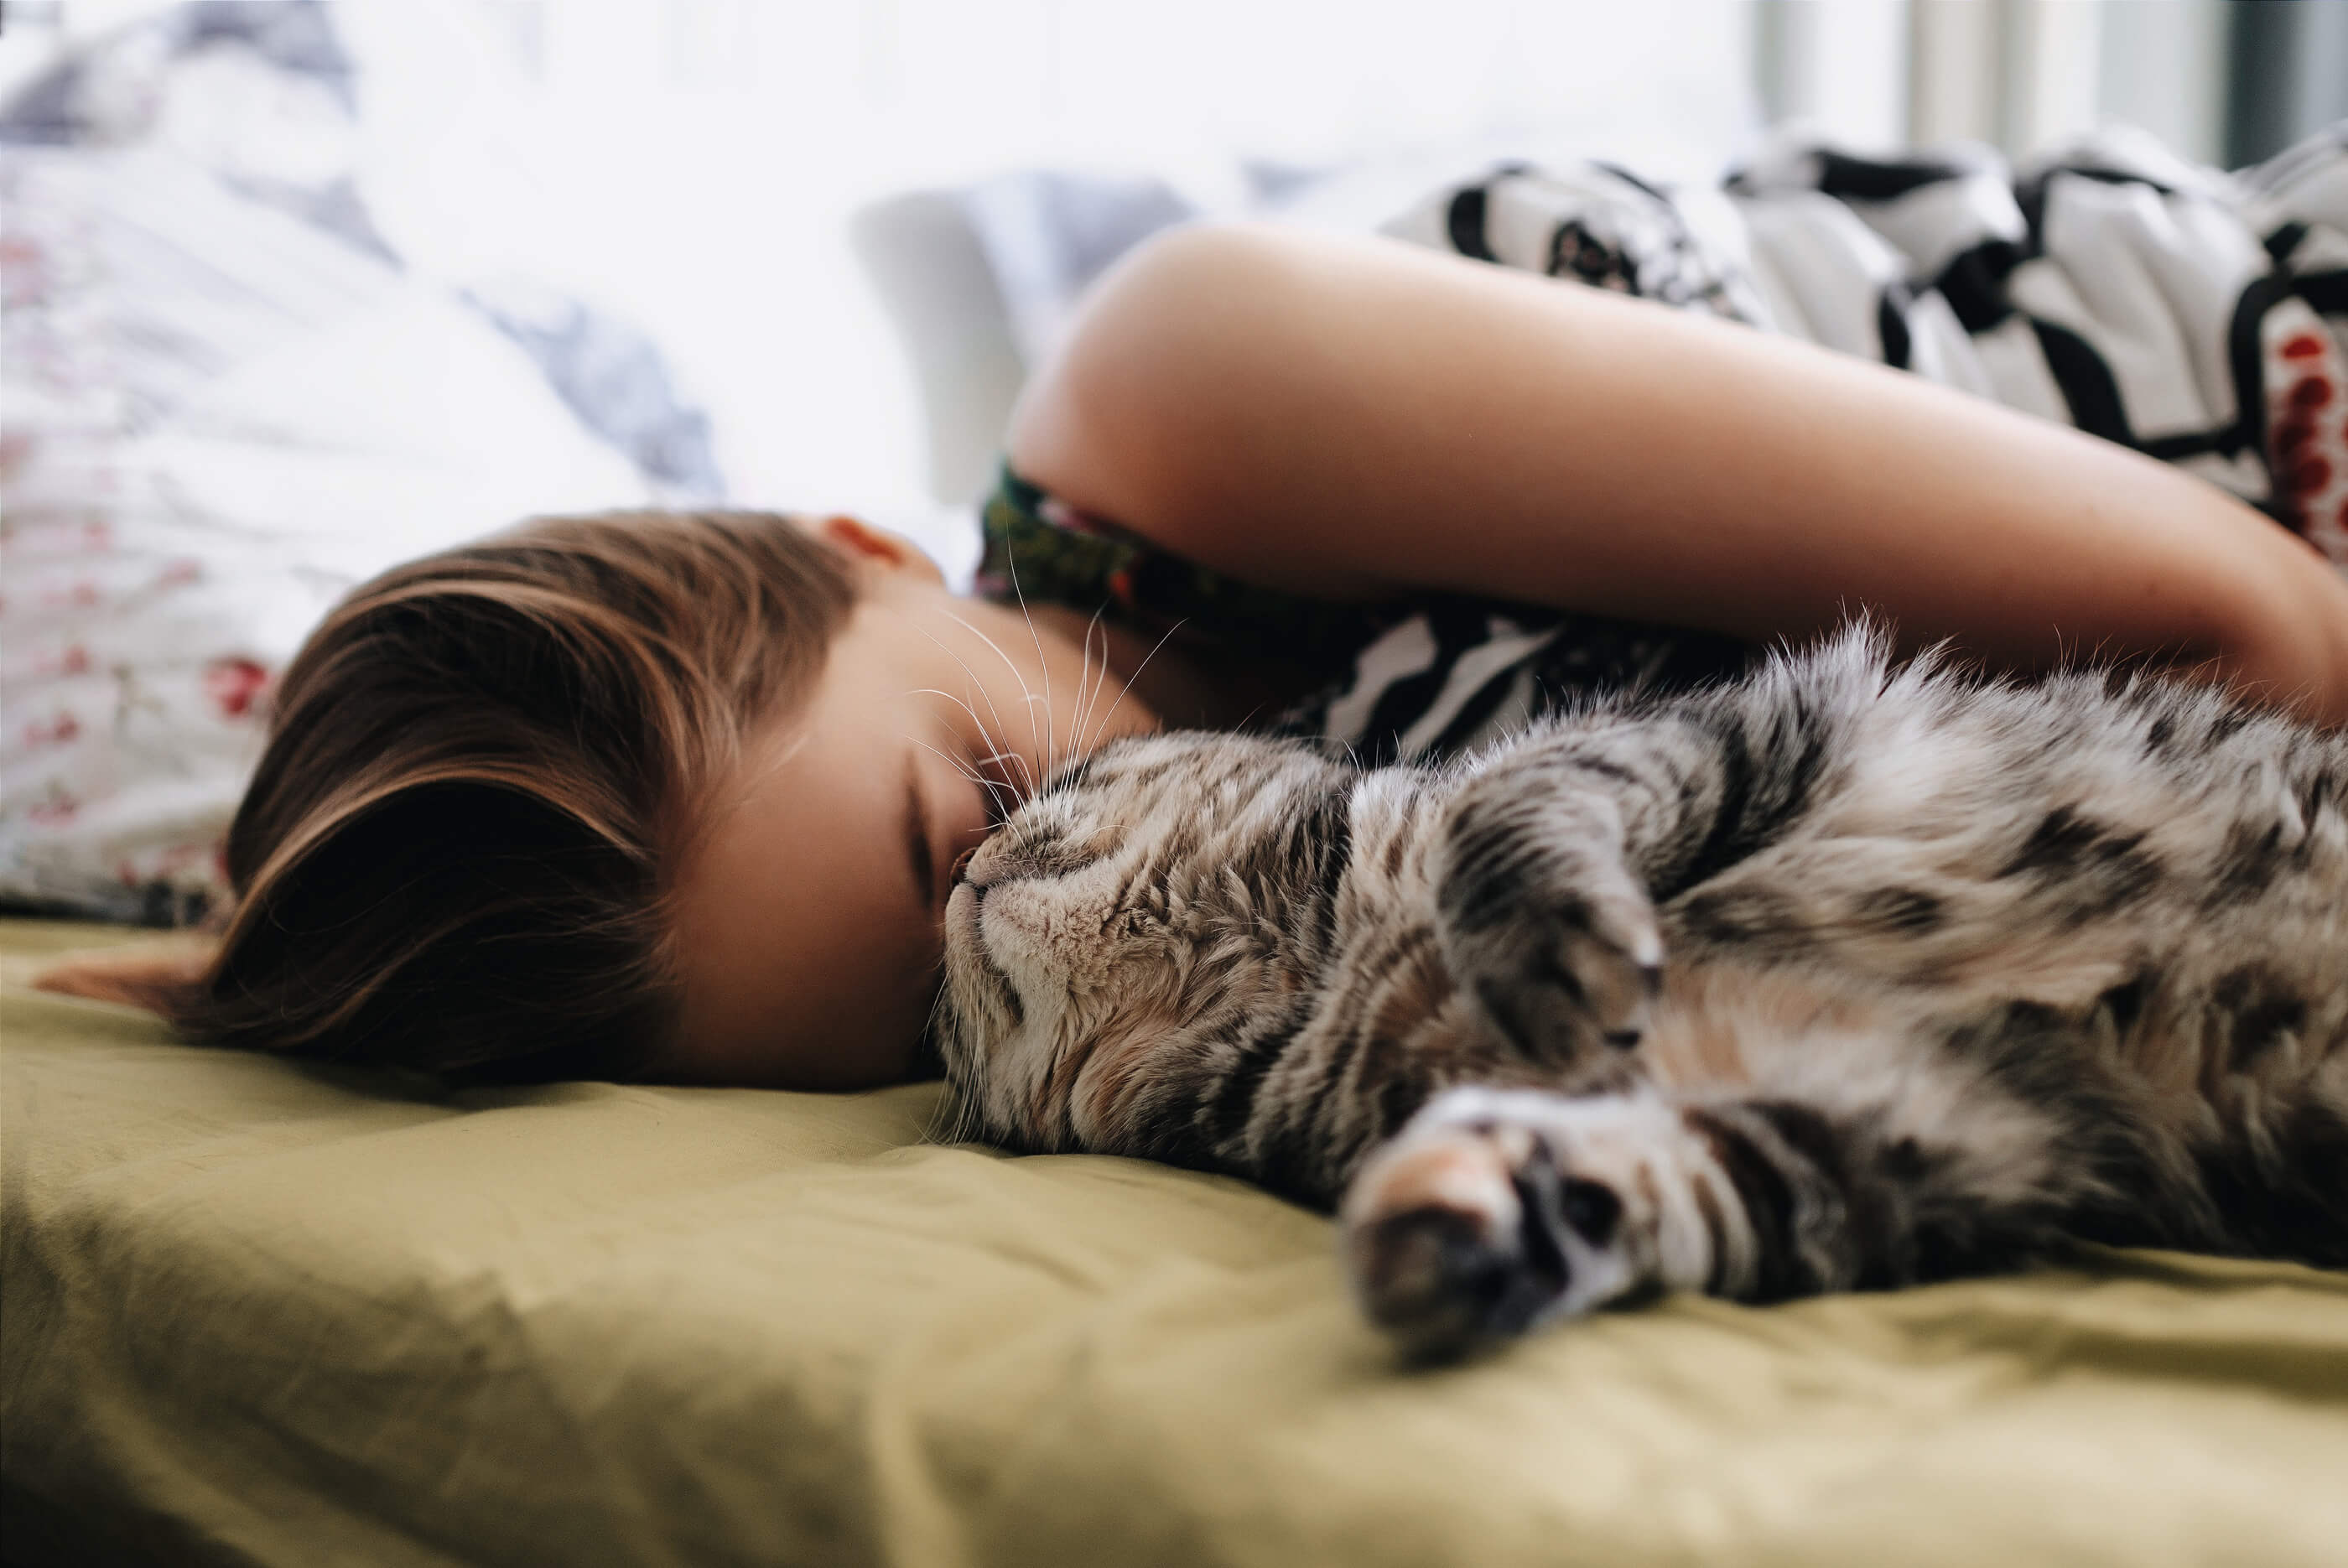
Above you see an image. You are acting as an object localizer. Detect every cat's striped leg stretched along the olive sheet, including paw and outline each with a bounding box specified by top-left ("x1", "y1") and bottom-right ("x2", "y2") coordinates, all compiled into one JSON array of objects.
[{"x1": 1338, "y1": 1089, "x2": 2095, "y2": 1354}]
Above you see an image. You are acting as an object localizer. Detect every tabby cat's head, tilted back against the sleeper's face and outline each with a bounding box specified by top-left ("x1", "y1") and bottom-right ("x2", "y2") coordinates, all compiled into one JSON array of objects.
[{"x1": 937, "y1": 735, "x2": 1355, "y2": 1150}]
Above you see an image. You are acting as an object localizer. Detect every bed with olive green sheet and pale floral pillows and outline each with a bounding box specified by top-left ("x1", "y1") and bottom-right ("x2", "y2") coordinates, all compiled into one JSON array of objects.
[{"x1": 0, "y1": 21, "x2": 2348, "y2": 1568}]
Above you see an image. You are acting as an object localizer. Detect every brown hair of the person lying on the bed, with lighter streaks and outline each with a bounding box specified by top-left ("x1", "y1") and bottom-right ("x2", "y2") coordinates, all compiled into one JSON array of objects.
[{"x1": 171, "y1": 511, "x2": 855, "y2": 1083}]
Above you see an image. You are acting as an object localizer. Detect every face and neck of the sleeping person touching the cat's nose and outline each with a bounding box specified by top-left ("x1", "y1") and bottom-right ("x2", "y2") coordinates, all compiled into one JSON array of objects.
[{"x1": 660, "y1": 530, "x2": 1156, "y2": 1089}]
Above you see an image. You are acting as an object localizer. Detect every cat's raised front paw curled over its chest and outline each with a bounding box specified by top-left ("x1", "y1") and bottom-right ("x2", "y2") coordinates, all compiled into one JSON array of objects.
[{"x1": 1437, "y1": 801, "x2": 1662, "y2": 1063}]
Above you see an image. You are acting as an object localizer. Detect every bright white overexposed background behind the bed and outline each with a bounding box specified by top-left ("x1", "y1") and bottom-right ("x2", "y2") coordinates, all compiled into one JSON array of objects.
[{"x1": 338, "y1": 0, "x2": 1754, "y2": 526}]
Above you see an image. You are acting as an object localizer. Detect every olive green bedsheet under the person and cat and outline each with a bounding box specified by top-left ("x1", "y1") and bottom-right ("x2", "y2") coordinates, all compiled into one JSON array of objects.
[{"x1": 0, "y1": 922, "x2": 2348, "y2": 1568}]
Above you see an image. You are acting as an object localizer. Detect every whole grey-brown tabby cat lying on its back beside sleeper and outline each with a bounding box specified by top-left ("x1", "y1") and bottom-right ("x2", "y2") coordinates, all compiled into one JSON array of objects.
[{"x1": 939, "y1": 629, "x2": 2348, "y2": 1354}]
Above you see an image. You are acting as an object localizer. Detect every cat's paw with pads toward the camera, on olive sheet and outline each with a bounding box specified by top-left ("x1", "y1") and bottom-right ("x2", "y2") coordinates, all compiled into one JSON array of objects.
[{"x1": 1338, "y1": 1089, "x2": 1688, "y2": 1357}]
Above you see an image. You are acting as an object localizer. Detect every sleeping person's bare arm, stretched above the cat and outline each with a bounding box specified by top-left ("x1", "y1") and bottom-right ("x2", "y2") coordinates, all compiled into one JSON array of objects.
[{"x1": 1012, "y1": 228, "x2": 2348, "y2": 723}]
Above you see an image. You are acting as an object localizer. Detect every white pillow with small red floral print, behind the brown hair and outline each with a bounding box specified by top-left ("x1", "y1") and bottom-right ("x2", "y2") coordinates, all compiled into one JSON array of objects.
[{"x1": 0, "y1": 148, "x2": 648, "y2": 922}]
